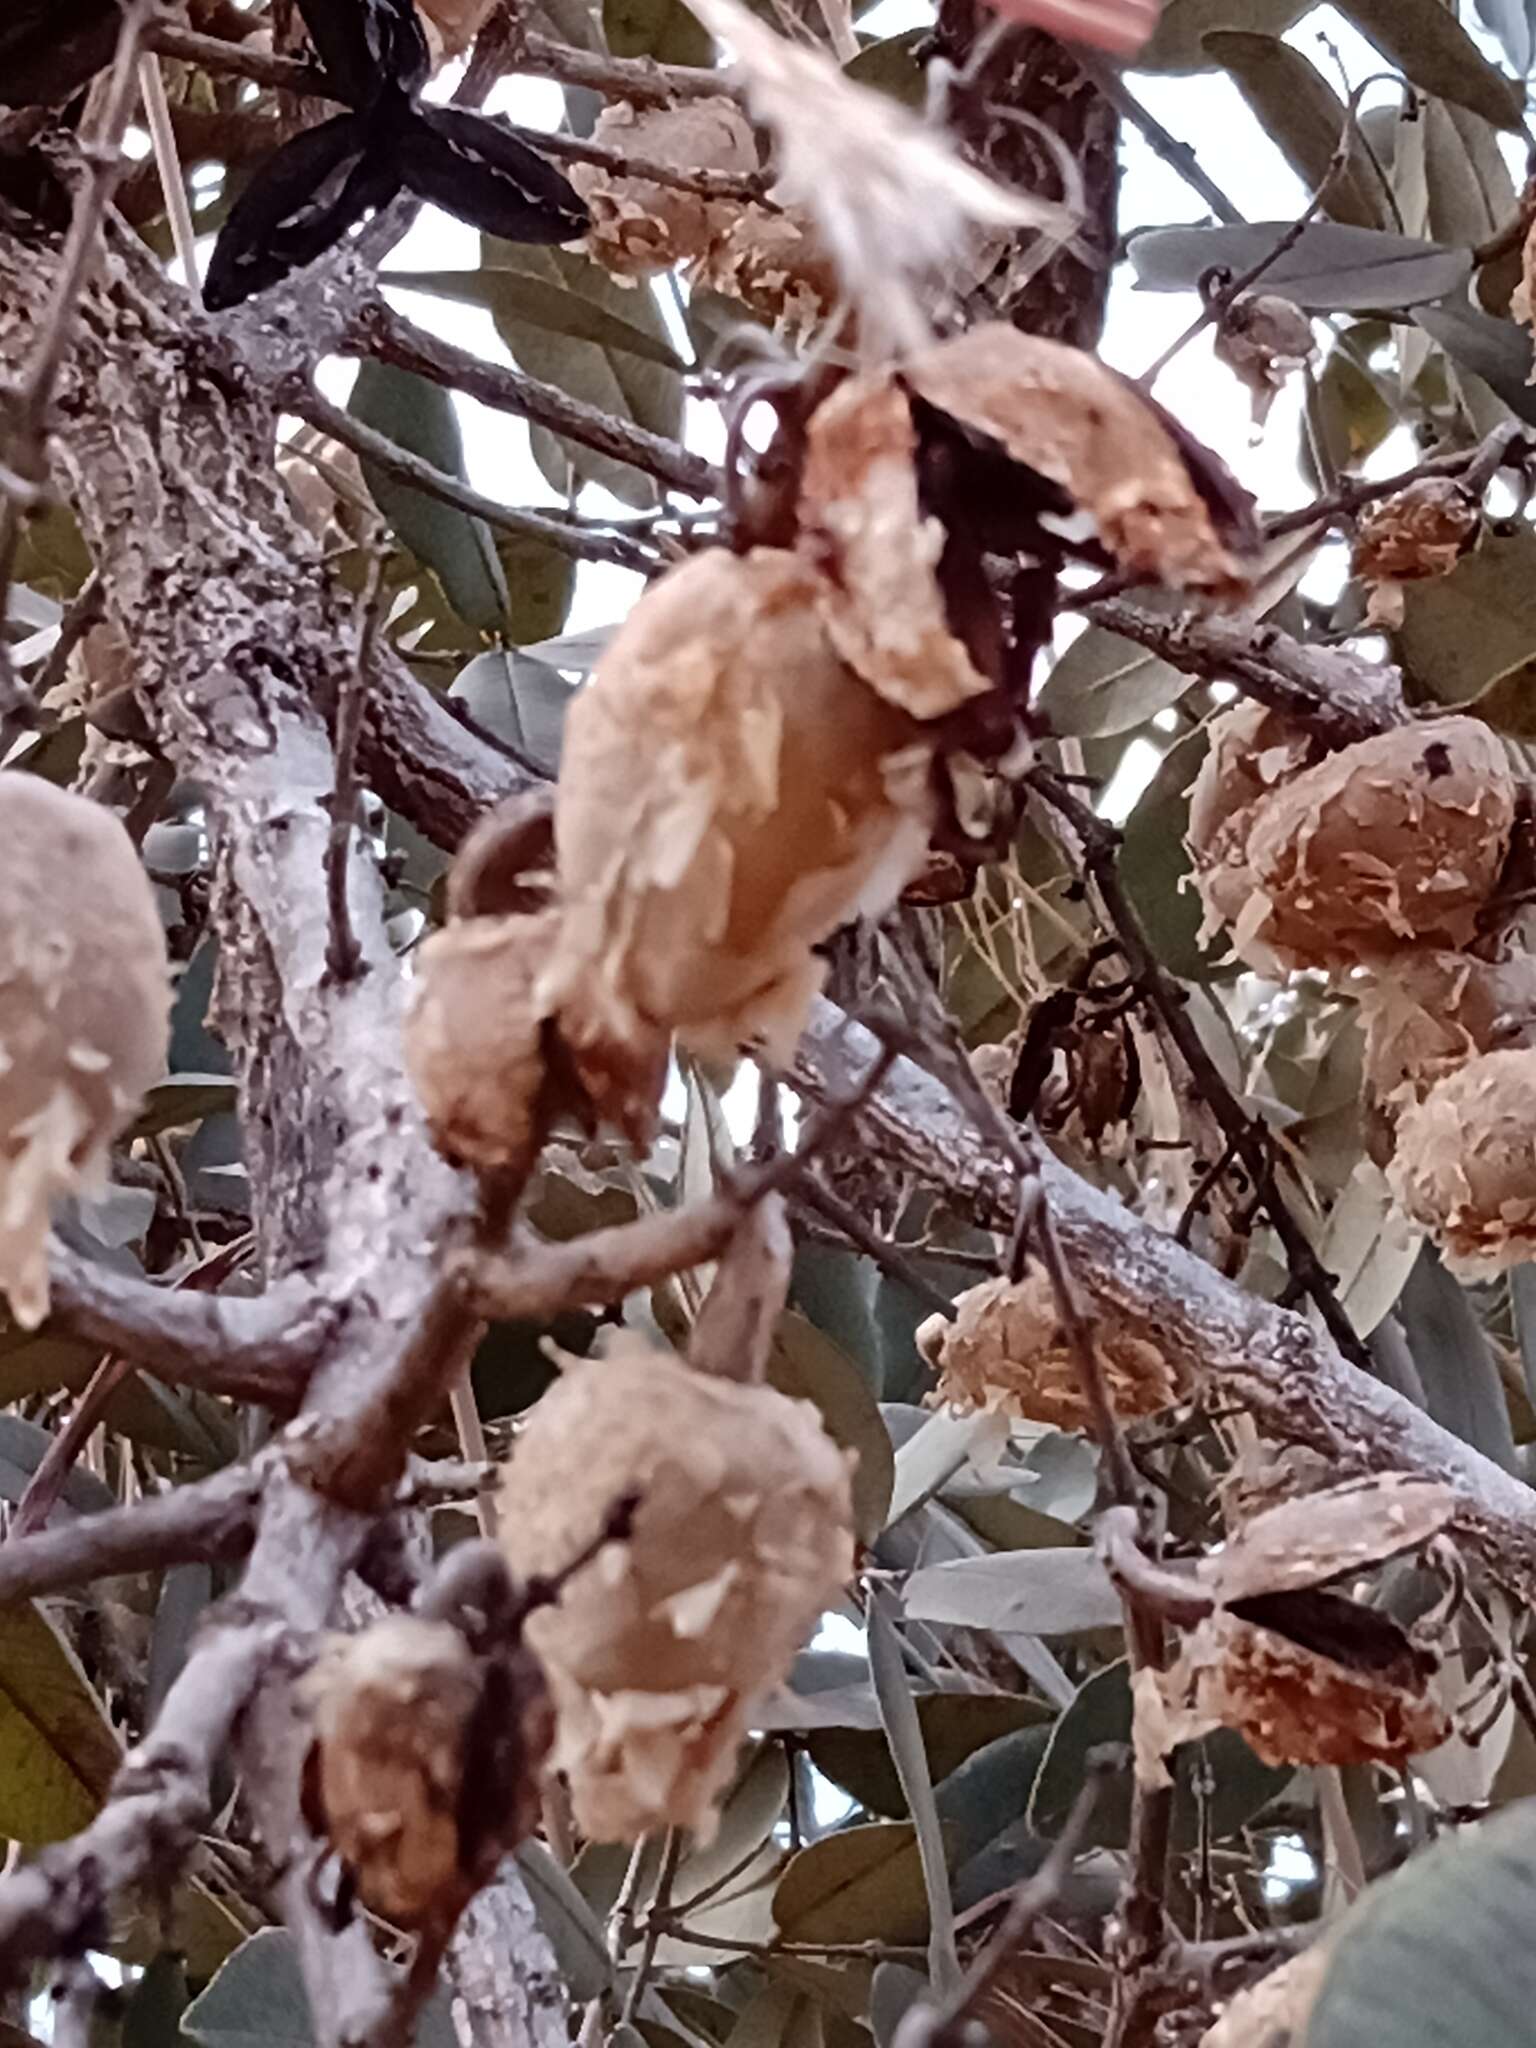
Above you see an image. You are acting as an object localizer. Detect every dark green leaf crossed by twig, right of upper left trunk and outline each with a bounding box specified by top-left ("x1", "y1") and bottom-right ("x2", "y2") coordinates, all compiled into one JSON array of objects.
[{"x1": 346, "y1": 360, "x2": 506, "y2": 633}]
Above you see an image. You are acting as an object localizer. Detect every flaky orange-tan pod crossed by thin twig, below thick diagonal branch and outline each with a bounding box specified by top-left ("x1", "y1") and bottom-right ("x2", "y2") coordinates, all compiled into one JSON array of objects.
[{"x1": 918, "y1": 1268, "x2": 1180, "y2": 1430}]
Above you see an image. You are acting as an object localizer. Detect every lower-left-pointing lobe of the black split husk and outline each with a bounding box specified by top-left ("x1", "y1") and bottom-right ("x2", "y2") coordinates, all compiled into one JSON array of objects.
[{"x1": 203, "y1": 115, "x2": 399, "y2": 313}]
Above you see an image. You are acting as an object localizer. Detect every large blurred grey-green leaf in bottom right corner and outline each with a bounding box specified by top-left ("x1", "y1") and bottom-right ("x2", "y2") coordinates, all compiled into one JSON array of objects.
[{"x1": 1307, "y1": 1800, "x2": 1536, "y2": 2048}]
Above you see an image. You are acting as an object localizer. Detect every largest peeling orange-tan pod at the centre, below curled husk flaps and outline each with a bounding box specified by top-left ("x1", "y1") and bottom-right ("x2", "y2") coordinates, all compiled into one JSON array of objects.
[{"x1": 539, "y1": 549, "x2": 932, "y2": 1135}]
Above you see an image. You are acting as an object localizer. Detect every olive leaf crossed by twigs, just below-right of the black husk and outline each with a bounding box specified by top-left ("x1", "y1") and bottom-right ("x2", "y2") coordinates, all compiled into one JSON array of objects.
[{"x1": 483, "y1": 240, "x2": 684, "y2": 510}]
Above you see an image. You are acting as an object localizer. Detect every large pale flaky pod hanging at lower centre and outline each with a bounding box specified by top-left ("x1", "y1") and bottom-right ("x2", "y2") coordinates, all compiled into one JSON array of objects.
[{"x1": 500, "y1": 1335, "x2": 854, "y2": 1841}]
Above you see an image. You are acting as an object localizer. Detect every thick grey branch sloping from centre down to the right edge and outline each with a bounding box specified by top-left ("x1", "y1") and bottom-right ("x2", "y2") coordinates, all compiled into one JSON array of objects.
[{"x1": 797, "y1": 1001, "x2": 1536, "y2": 1599}]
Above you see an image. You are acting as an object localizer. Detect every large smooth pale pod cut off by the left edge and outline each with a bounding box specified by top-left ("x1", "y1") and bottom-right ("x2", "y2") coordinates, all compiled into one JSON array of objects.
[{"x1": 0, "y1": 770, "x2": 170, "y2": 1329}]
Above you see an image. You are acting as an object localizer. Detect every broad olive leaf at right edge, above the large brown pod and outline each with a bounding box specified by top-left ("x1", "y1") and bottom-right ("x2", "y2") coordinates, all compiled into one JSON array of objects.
[{"x1": 1393, "y1": 522, "x2": 1536, "y2": 705}]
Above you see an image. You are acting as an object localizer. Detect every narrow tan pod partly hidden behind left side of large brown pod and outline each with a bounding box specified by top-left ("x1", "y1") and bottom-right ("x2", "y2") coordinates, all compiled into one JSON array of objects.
[{"x1": 1186, "y1": 698, "x2": 1321, "y2": 938}]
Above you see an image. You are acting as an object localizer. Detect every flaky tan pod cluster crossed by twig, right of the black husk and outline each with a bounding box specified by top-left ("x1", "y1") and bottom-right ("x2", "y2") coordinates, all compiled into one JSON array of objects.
[{"x1": 571, "y1": 96, "x2": 758, "y2": 279}]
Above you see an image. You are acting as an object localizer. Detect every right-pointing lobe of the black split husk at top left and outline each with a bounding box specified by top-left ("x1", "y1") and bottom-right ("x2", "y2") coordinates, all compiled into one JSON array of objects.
[{"x1": 393, "y1": 106, "x2": 588, "y2": 242}]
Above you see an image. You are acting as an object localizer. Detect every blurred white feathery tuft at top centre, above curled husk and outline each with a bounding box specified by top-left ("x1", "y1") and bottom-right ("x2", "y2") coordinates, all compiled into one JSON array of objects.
[{"x1": 690, "y1": 0, "x2": 1073, "y2": 360}]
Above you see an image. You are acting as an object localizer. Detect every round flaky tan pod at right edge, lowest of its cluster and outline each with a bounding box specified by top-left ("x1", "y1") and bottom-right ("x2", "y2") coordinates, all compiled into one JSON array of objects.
[{"x1": 1386, "y1": 1049, "x2": 1536, "y2": 1280}]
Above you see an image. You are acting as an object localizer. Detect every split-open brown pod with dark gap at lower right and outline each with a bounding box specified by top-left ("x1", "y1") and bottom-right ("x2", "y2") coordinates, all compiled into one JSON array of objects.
[{"x1": 1137, "y1": 1473, "x2": 1456, "y2": 1784}]
